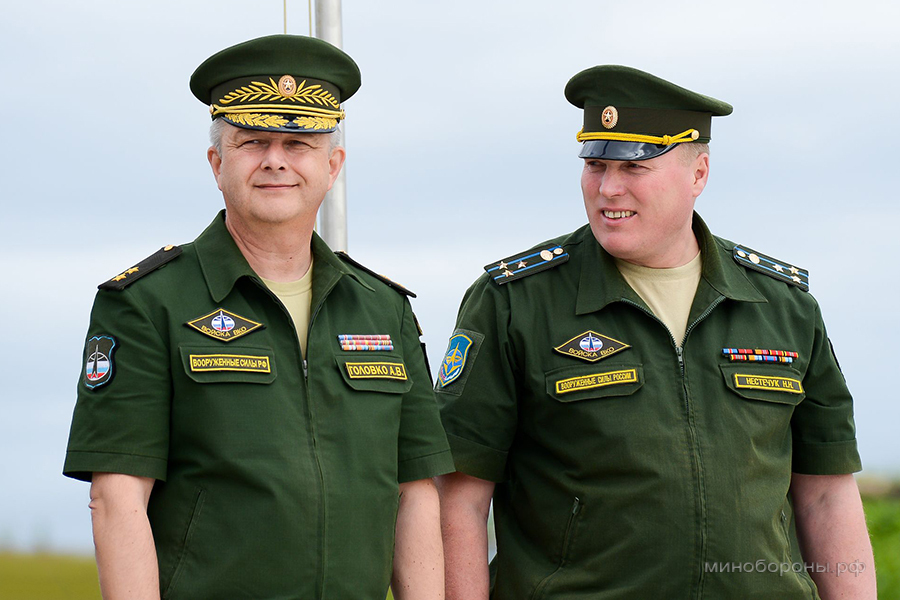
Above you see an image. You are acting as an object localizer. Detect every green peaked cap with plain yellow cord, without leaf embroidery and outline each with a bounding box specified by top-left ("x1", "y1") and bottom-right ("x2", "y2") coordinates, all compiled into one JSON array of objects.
[{"x1": 566, "y1": 65, "x2": 732, "y2": 161}]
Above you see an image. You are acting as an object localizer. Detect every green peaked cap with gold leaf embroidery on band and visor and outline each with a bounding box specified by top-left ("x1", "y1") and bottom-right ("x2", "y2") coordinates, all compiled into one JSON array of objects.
[{"x1": 191, "y1": 35, "x2": 360, "y2": 133}]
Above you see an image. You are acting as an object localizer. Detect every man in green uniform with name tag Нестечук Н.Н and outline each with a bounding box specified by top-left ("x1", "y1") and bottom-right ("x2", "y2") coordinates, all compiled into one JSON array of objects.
[{"x1": 436, "y1": 66, "x2": 875, "y2": 600}]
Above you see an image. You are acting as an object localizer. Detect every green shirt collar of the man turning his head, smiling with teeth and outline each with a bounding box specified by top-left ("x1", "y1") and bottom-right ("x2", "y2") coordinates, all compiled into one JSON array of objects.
[{"x1": 575, "y1": 213, "x2": 766, "y2": 315}]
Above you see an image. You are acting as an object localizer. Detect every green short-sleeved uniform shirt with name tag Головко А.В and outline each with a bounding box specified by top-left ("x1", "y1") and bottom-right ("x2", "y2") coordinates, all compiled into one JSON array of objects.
[{"x1": 64, "y1": 212, "x2": 453, "y2": 600}]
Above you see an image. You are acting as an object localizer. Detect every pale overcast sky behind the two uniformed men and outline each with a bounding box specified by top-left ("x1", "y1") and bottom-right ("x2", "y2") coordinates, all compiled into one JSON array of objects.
[{"x1": 0, "y1": 0, "x2": 900, "y2": 551}]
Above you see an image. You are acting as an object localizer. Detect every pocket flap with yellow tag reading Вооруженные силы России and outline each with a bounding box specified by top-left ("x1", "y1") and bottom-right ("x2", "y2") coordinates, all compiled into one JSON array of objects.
[{"x1": 545, "y1": 364, "x2": 644, "y2": 402}]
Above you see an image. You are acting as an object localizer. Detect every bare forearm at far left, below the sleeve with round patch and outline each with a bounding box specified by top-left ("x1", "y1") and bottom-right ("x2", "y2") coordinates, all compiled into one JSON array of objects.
[{"x1": 90, "y1": 473, "x2": 159, "y2": 600}]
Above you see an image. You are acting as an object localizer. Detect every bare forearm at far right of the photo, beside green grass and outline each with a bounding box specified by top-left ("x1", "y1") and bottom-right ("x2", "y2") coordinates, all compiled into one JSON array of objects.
[{"x1": 791, "y1": 473, "x2": 876, "y2": 600}]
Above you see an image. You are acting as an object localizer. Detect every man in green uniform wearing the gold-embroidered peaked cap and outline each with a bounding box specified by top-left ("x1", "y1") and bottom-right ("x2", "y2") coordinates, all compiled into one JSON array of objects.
[{"x1": 64, "y1": 35, "x2": 453, "y2": 600}]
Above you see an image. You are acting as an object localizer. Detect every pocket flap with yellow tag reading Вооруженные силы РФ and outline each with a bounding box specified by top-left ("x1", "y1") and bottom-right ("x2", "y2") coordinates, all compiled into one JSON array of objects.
[{"x1": 179, "y1": 346, "x2": 275, "y2": 383}]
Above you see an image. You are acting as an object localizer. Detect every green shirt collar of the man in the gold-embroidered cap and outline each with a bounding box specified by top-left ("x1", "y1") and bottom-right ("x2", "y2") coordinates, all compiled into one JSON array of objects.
[{"x1": 194, "y1": 210, "x2": 372, "y2": 302}]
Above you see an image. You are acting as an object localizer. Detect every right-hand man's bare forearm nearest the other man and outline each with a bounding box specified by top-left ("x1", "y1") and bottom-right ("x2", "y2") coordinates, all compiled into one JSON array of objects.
[{"x1": 437, "y1": 472, "x2": 494, "y2": 600}]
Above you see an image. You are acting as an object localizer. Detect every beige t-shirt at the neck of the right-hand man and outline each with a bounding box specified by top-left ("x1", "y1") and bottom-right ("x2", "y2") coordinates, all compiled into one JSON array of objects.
[{"x1": 616, "y1": 252, "x2": 703, "y2": 347}]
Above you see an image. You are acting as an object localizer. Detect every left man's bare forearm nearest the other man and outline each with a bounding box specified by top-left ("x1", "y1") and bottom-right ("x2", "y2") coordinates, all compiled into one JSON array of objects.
[{"x1": 391, "y1": 479, "x2": 444, "y2": 600}]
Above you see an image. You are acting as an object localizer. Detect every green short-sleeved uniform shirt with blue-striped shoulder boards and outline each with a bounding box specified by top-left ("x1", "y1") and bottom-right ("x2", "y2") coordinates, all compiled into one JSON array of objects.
[{"x1": 436, "y1": 217, "x2": 860, "y2": 600}]
